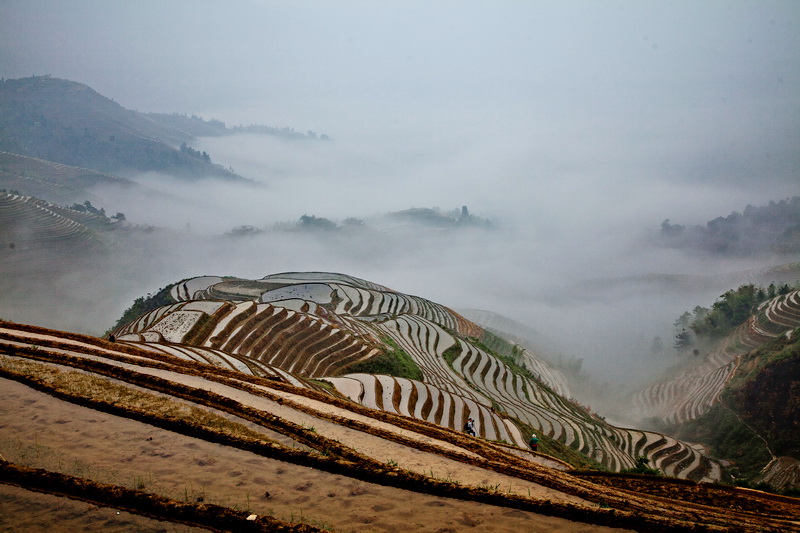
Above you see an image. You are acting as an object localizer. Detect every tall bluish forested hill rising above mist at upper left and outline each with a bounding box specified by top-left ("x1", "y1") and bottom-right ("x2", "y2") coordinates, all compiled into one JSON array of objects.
[{"x1": 0, "y1": 76, "x2": 246, "y2": 181}]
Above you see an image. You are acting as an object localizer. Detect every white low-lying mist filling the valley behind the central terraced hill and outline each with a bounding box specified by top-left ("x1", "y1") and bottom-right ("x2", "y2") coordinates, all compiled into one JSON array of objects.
[{"x1": 73, "y1": 128, "x2": 791, "y2": 390}]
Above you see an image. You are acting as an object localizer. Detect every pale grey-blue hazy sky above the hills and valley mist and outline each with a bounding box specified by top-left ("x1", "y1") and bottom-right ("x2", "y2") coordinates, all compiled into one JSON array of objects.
[{"x1": 0, "y1": 0, "x2": 800, "y2": 211}]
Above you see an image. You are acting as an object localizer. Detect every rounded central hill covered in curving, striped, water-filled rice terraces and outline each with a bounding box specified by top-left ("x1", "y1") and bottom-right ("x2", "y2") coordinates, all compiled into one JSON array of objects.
[{"x1": 115, "y1": 272, "x2": 721, "y2": 481}]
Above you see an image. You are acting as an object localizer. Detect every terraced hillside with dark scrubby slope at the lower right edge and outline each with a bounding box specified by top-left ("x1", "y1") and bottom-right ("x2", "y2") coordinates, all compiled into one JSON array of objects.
[{"x1": 634, "y1": 291, "x2": 800, "y2": 489}]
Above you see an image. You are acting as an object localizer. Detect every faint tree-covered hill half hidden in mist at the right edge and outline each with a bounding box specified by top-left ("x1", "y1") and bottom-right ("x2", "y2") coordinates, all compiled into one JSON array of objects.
[{"x1": 659, "y1": 196, "x2": 800, "y2": 256}]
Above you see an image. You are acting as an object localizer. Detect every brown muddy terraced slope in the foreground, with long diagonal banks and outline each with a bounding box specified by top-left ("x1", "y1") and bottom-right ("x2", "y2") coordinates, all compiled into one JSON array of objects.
[{"x1": 0, "y1": 322, "x2": 800, "y2": 532}]
